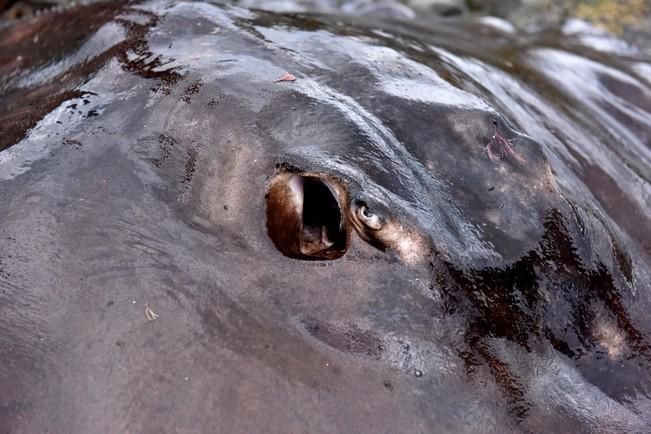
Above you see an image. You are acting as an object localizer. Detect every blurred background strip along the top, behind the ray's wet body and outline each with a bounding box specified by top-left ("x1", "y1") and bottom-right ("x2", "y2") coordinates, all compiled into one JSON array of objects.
[{"x1": 0, "y1": 0, "x2": 651, "y2": 42}]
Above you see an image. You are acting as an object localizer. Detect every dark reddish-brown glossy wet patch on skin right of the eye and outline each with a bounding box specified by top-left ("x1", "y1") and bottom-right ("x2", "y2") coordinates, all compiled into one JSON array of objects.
[{"x1": 437, "y1": 210, "x2": 651, "y2": 400}]
